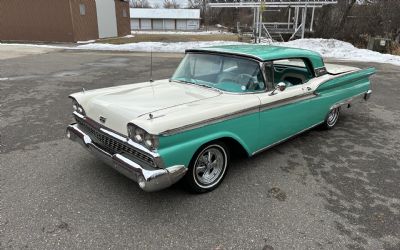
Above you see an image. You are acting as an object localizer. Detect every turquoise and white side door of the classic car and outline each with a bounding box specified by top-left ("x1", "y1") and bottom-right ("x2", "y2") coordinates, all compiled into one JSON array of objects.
[{"x1": 258, "y1": 59, "x2": 316, "y2": 151}]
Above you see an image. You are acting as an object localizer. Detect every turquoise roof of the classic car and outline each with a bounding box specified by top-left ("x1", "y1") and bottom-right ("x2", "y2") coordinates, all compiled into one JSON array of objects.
[{"x1": 186, "y1": 44, "x2": 324, "y2": 68}]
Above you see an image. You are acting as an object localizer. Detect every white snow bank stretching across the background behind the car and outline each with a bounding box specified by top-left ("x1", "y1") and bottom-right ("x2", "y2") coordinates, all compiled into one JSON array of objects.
[{"x1": 0, "y1": 38, "x2": 400, "y2": 66}]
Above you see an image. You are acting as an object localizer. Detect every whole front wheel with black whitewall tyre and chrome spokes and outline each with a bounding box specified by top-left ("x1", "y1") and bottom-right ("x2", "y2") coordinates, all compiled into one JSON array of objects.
[{"x1": 184, "y1": 142, "x2": 229, "y2": 193}]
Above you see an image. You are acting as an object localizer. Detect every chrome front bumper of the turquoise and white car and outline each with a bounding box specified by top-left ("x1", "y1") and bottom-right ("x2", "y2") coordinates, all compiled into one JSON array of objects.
[{"x1": 66, "y1": 124, "x2": 187, "y2": 192}]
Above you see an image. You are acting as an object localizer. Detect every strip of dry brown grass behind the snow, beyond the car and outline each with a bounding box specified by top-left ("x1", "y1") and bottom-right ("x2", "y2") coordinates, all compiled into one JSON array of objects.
[{"x1": 96, "y1": 34, "x2": 239, "y2": 44}]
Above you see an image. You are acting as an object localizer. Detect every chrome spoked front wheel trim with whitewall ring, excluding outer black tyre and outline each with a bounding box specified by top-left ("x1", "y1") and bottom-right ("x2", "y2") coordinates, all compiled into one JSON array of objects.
[{"x1": 192, "y1": 144, "x2": 227, "y2": 188}]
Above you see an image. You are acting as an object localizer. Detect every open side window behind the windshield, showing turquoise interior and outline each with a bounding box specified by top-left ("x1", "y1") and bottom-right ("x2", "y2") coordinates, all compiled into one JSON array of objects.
[{"x1": 273, "y1": 58, "x2": 312, "y2": 87}]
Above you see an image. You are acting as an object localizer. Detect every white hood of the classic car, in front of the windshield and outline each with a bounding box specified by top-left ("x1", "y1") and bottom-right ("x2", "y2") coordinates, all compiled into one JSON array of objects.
[{"x1": 71, "y1": 80, "x2": 220, "y2": 134}]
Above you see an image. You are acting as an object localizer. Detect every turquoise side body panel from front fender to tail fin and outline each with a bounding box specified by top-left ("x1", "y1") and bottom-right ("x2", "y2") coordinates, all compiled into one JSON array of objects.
[{"x1": 158, "y1": 61, "x2": 375, "y2": 169}]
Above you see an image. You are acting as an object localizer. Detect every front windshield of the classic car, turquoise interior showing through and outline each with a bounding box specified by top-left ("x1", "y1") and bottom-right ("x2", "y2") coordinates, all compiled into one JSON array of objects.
[{"x1": 171, "y1": 53, "x2": 265, "y2": 93}]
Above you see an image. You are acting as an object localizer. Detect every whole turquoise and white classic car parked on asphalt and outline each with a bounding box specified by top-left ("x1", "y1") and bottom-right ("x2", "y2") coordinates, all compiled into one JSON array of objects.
[{"x1": 66, "y1": 45, "x2": 375, "y2": 193}]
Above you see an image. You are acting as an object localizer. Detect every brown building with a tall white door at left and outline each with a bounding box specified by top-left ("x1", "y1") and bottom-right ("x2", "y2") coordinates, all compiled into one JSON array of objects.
[{"x1": 0, "y1": 0, "x2": 131, "y2": 42}]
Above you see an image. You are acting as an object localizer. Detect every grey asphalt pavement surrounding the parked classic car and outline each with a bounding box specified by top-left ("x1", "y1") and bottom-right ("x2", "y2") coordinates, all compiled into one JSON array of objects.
[{"x1": 0, "y1": 47, "x2": 400, "y2": 249}]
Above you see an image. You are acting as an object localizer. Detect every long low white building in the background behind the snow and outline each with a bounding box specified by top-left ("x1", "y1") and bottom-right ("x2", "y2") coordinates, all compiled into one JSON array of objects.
[{"x1": 130, "y1": 8, "x2": 200, "y2": 30}]
